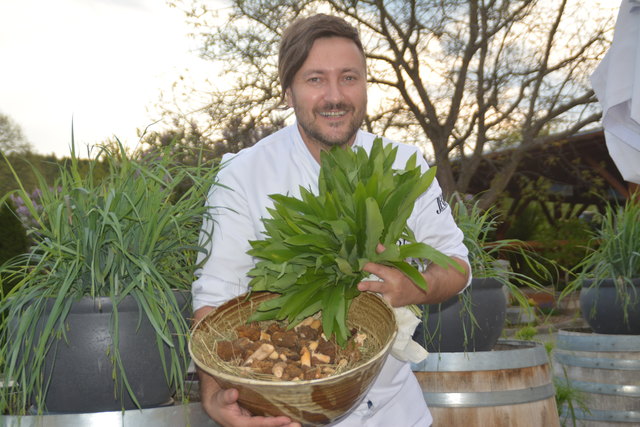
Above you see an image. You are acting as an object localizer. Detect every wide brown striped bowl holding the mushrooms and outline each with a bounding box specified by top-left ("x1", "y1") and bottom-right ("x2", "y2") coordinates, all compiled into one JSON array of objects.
[{"x1": 189, "y1": 293, "x2": 397, "y2": 426}]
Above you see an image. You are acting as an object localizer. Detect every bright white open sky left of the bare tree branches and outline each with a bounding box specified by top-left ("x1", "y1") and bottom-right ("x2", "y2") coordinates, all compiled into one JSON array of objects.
[{"x1": 0, "y1": 0, "x2": 223, "y2": 157}]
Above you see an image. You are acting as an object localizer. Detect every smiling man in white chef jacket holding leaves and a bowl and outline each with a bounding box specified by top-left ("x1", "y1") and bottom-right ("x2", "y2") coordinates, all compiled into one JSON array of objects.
[{"x1": 193, "y1": 14, "x2": 470, "y2": 426}]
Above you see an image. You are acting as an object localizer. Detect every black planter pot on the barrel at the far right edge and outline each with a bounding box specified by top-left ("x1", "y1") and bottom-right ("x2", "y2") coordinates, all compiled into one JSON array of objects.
[{"x1": 580, "y1": 278, "x2": 640, "y2": 335}]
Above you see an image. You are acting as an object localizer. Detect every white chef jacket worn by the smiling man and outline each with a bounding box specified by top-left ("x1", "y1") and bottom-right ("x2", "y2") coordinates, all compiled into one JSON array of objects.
[{"x1": 192, "y1": 124, "x2": 468, "y2": 427}]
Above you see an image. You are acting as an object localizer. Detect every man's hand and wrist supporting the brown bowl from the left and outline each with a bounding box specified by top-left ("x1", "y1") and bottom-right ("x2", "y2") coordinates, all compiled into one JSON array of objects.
[{"x1": 194, "y1": 307, "x2": 300, "y2": 427}]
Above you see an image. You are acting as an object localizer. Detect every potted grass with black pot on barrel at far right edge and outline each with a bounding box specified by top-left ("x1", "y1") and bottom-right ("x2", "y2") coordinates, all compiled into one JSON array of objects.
[{"x1": 561, "y1": 194, "x2": 640, "y2": 335}]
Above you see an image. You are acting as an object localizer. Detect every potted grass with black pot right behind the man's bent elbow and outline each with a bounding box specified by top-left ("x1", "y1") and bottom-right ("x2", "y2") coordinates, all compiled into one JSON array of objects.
[{"x1": 414, "y1": 194, "x2": 548, "y2": 353}]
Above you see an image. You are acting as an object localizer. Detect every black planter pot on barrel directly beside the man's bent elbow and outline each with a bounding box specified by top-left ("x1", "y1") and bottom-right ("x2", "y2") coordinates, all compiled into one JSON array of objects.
[{"x1": 413, "y1": 278, "x2": 507, "y2": 353}]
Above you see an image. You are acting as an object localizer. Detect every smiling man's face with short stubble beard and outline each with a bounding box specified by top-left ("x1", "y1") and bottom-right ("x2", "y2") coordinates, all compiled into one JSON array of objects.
[{"x1": 286, "y1": 37, "x2": 367, "y2": 148}]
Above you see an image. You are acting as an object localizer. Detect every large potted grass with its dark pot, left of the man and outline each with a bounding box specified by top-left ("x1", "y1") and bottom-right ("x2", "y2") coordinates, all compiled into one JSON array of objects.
[{"x1": 0, "y1": 143, "x2": 217, "y2": 415}]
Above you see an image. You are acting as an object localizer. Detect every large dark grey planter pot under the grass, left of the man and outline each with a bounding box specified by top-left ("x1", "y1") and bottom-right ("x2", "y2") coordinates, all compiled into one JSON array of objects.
[{"x1": 34, "y1": 292, "x2": 191, "y2": 413}]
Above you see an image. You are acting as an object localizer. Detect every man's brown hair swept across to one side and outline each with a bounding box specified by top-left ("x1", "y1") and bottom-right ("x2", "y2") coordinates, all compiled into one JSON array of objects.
[{"x1": 278, "y1": 13, "x2": 365, "y2": 96}]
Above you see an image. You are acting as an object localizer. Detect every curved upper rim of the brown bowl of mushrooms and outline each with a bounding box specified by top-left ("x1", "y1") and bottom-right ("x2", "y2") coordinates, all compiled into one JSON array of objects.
[{"x1": 188, "y1": 292, "x2": 398, "y2": 387}]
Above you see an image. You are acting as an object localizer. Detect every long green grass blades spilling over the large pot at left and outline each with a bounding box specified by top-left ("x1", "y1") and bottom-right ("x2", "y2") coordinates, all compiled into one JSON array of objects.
[{"x1": 0, "y1": 140, "x2": 218, "y2": 412}]
